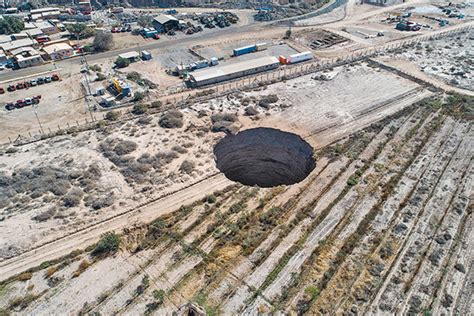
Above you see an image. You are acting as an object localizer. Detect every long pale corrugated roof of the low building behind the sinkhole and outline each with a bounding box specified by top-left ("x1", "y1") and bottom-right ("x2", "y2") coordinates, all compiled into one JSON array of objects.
[{"x1": 191, "y1": 56, "x2": 279, "y2": 82}]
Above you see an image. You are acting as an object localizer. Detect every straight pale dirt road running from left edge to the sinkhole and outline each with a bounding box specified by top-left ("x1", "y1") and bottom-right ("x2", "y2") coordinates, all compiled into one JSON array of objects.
[{"x1": 0, "y1": 174, "x2": 232, "y2": 280}]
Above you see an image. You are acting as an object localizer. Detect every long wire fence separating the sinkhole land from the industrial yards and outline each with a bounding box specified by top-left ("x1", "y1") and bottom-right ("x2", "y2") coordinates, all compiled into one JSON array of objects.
[{"x1": 4, "y1": 24, "x2": 473, "y2": 146}]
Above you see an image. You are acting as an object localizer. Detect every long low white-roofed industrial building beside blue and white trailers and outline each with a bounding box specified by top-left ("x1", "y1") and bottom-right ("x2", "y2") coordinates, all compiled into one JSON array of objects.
[{"x1": 189, "y1": 56, "x2": 280, "y2": 87}]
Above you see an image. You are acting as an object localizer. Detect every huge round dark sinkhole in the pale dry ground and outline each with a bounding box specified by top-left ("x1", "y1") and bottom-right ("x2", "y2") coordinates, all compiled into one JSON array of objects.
[{"x1": 214, "y1": 128, "x2": 316, "y2": 188}]
